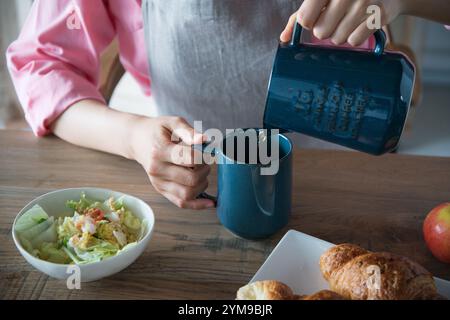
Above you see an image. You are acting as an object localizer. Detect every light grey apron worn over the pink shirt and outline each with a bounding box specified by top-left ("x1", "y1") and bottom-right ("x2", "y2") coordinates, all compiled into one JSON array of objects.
[{"x1": 142, "y1": 0, "x2": 344, "y2": 150}]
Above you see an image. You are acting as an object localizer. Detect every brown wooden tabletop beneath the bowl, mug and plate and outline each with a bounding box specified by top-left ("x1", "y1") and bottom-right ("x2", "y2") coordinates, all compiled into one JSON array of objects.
[{"x1": 0, "y1": 131, "x2": 450, "y2": 299}]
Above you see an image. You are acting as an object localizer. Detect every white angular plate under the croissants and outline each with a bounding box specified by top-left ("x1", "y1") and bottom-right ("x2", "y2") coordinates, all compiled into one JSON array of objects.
[{"x1": 250, "y1": 230, "x2": 450, "y2": 299}]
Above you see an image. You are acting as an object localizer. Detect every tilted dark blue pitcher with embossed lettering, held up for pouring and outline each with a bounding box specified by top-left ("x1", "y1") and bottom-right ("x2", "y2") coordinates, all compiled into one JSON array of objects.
[{"x1": 264, "y1": 24, "x2": 415, "y2": 155}]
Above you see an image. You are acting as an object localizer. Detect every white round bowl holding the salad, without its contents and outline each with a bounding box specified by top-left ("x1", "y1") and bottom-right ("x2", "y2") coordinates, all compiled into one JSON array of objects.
[{"x1": 12, "y1": 188, "x2": 155, "y2": 282}]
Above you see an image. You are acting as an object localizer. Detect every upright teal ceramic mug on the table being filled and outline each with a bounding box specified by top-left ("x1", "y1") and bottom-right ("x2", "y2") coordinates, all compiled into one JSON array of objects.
[{"x1": 194, "y1": 129, "x2": 293, "y2": 239}]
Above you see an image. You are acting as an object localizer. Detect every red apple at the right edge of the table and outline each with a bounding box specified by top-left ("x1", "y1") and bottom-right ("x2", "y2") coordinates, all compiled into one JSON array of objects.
[{"x1": 423, "y1": 203, "x2": 450, "y2": 263}]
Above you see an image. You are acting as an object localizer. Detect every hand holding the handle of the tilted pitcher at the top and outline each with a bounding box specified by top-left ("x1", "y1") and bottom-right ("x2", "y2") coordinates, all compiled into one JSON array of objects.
[{"x1": 280, "y1": 0, "x2": 409, "y2": 46}]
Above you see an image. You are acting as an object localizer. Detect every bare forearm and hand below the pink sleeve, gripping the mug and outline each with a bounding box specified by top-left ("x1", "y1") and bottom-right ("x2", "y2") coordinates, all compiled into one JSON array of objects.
[{"x1": 52, "y1": 100, "x2": 214, "y2": 209}]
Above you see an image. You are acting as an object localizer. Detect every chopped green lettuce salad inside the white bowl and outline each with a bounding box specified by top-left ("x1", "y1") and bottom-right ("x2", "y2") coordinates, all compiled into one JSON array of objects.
[{"x1": 15, "y1": 193, "x2": 145, "y2": 264}]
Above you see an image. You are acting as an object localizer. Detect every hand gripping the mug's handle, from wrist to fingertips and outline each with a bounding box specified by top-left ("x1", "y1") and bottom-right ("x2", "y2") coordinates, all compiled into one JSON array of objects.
[{"x1": 131, "y1": 117, "x2": 215, "y2": 210}]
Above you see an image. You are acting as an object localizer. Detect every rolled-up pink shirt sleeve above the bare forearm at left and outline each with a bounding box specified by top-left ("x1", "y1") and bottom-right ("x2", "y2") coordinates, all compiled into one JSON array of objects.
[{"x1": 7, "y1": 0, "x2": 115, "y2": 136}]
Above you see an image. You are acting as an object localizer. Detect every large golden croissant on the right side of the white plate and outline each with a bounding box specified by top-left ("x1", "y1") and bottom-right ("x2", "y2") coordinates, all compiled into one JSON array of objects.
[{"x1": 320, "y1": 244, "x2": 442, "y2": 300}]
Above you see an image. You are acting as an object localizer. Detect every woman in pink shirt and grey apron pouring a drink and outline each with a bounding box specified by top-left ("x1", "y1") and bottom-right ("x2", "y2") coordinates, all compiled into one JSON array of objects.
[{"x1": 7, "y1": 0, "x2": 450, "y2": 209}]
